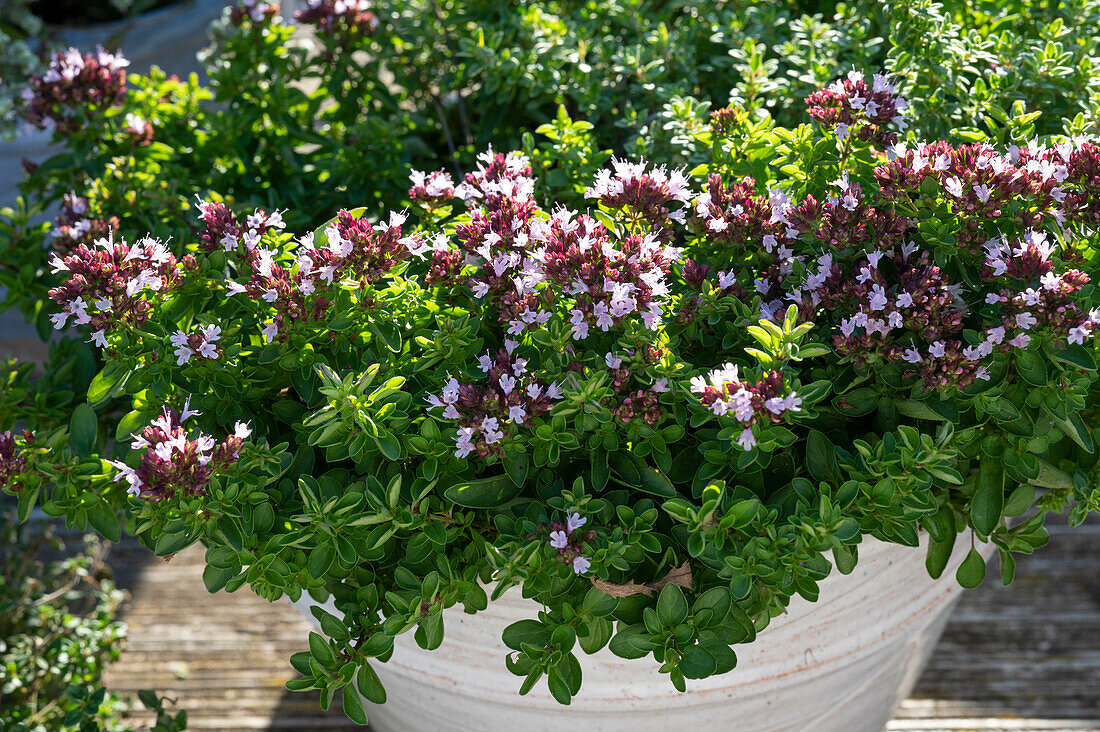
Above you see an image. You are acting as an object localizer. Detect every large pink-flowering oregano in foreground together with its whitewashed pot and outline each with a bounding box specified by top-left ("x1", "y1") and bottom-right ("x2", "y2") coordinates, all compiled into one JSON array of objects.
[{"x1": 4, "y1": 59, "x2": 1100, "y2": 729}]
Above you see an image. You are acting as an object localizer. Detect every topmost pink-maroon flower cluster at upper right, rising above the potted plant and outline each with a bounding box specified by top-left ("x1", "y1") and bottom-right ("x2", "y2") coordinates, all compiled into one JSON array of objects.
[{"x1": 806, "y1": 69, "x2": 909, "y2": 146}]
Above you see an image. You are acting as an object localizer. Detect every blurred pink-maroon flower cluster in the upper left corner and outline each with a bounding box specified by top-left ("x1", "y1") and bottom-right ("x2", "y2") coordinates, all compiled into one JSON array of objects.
[{"x1": 23, "y1": 48, "x2": 130, "y2": 134}]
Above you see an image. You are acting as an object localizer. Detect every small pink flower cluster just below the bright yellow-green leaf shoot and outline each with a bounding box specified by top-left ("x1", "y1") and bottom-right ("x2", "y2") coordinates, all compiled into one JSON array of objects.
[{"x1": 691, "y1": 363, "x2": 802, "y2": 451}]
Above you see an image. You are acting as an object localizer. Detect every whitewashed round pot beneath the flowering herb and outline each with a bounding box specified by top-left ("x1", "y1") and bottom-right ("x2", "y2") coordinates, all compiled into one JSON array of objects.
[{"x1": 295, "y1": 530, "x2": 969, "y2": 732}]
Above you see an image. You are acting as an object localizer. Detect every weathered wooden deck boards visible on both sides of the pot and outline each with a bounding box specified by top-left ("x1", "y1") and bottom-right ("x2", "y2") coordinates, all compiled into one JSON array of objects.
[{"x1": 96, "y1": 522, "x2": 1100, "y2": 732}]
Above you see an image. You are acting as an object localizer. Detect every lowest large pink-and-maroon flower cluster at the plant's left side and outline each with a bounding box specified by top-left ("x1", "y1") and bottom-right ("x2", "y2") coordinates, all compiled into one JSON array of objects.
[{"x1": 110, "y1": 400, "x2": 252, "y2": 501}]
